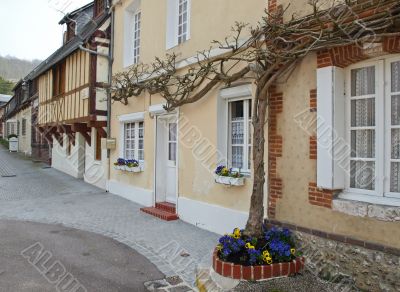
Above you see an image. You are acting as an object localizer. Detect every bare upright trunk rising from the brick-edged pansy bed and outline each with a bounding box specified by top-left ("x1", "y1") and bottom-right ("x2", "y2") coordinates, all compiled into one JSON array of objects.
[{"x1": 245, "y1": 91, "x2": 268, "y2": 237}]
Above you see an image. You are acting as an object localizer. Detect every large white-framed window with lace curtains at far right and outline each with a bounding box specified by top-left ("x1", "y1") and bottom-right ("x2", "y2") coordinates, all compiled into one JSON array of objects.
[{"x1": 346, "y1": 57, "x2": 400, "y2": 198}]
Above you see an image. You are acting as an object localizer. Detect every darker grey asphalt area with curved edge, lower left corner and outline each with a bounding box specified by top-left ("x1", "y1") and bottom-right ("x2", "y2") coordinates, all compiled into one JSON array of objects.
[{"x1": 0, "y1": 220, "x2": 164, "y2": 292}]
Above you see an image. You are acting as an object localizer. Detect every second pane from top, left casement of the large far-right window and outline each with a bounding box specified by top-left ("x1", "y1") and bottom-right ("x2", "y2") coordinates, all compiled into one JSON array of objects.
[{"x1": 351, "y1": 98, "x2": 375, "y2": 127}]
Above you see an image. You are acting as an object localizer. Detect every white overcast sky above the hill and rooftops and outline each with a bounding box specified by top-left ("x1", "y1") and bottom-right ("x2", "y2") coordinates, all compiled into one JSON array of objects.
[{"x1": 0, "y1": 0, "x2": 91, "y2": 60}]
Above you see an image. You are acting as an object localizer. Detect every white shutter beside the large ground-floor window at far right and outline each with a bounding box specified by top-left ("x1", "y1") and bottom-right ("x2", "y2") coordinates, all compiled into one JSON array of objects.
[{"x1": 317, "y1": 66, "x2": 349, "y2": 190}]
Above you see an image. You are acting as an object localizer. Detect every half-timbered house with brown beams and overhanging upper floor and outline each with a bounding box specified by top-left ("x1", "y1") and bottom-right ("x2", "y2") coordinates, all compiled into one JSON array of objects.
[{"x1": 30, "y1": 0, "x2": 110, "y2": 188}]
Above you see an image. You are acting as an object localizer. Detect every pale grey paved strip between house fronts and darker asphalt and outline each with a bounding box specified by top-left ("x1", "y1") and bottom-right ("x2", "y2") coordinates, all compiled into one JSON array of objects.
[{"x1": 0, "y1": 146, "x2": 218, "y2": 290}]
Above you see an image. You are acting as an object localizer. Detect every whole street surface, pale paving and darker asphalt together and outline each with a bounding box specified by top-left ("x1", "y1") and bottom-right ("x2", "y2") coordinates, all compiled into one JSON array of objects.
[{"x1": 0, "y1": 148, "x2": 218, "y2": 291}]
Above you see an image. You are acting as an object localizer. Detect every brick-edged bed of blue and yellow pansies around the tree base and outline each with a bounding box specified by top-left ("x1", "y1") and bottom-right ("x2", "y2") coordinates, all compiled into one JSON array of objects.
[{"x1": 213, "y1": 227, "x2": 305, "y2": 281}]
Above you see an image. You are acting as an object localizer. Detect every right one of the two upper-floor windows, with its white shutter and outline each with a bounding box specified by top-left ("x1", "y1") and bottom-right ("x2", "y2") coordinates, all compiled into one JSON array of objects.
[{"x1": 166, "y1": 0, "x2": 190, "y2": 49}]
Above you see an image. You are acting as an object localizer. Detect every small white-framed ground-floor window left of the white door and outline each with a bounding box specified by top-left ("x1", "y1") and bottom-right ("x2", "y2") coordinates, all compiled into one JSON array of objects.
[{"x1": 124, "y1": 122, "x2": 144, "y2": 161}]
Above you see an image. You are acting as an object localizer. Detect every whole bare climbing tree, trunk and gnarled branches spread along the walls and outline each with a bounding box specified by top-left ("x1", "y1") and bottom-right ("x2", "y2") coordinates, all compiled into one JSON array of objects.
[{"x1": 112, "y1": 0, "x2": 400, "y2": 236}]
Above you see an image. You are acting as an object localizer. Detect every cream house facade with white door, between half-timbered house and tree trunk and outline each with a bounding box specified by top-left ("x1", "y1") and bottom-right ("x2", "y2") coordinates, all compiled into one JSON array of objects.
[{"x1": 108, "y1": 0, "x2": 266, "y2": 233}]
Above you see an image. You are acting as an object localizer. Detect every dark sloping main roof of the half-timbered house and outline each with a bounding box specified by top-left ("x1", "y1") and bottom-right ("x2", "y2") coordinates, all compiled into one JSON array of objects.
[{"x1": 25, "y1": 13, "x2": 108, "y2": 80}]
